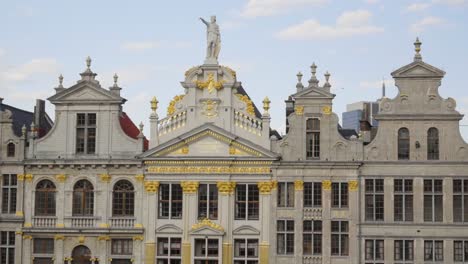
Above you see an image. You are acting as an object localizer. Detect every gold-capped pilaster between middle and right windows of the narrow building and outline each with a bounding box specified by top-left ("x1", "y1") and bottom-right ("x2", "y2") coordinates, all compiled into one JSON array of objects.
[{"x1": 322, "y1": 180, "x2": 332, "y2": 264}]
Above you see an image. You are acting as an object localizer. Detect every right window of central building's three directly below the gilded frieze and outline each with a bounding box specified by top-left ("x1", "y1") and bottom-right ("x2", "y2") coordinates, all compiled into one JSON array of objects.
[{"x1": 235, "y1": 184, "x2": 259, "y2": 220}]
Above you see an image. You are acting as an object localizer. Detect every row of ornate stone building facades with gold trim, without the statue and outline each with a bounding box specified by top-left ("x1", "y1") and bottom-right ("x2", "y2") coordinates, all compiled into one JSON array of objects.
[{"x1": 0, "y1": 37, "x2": 468, "y2": 264}]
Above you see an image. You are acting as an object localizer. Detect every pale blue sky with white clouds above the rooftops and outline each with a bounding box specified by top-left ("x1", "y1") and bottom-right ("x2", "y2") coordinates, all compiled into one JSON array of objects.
[{"x1": 0, "y1": 0, "x2": 468, "y2": 139}]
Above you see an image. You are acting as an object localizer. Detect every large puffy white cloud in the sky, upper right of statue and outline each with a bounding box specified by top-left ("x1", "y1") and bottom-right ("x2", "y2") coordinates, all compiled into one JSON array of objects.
[{"x1": 277, "y1": 10, "x2": 384, "y2": 40}]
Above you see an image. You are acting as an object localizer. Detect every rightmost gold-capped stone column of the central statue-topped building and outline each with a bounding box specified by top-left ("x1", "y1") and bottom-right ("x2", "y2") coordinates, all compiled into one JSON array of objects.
[{"x1": 257, "y1": 181, "x2": 274, "y2": 264}]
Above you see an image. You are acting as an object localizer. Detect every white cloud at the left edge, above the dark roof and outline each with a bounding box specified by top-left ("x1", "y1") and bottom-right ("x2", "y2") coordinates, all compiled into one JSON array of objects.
[{"x1": 0, "y1": 58, "x2": 59, "y2": 82}]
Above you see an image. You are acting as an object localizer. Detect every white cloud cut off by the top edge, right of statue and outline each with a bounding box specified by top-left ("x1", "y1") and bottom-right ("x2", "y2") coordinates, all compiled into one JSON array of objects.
[{"x1": 241, "y1": 0, "x2": 329, "y2": 17}]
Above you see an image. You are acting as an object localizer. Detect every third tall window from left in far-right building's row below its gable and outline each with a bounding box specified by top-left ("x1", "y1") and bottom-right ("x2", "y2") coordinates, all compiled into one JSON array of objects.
[{"x1": 424, "y1": 180, "x2": 444, "y2": 222}]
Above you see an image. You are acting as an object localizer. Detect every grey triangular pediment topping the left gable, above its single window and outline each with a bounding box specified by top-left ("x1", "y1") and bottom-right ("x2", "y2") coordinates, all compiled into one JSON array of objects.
[{"x1": 49, "y1": 82, "x2": 125, "y2": 103}]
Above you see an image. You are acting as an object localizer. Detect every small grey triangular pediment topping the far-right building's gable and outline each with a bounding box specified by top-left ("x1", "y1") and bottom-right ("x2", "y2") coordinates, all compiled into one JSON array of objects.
[{"x1": 392, "y1": 61, "x2": 445, "y2": 78}]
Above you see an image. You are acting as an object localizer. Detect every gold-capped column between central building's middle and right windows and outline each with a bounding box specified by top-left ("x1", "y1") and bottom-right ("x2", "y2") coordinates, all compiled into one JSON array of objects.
[{"x1": 217, "y1": 182, "x2": 236, "y2": 264}]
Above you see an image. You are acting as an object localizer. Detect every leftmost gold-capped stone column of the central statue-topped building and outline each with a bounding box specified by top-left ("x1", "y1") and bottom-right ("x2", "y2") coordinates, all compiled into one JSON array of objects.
[{"x1": 143, "y1": 181, "x2": 159, "y2": 264}]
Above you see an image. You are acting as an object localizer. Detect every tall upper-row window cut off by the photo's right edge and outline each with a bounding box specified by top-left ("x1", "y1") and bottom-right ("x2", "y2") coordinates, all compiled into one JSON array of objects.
[{"x1": 453, "y1": 179, "x2": 468, "y2": 222}]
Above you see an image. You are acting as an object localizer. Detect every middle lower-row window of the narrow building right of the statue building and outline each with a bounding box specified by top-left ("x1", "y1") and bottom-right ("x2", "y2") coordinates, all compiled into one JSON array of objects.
[{"x1": 302, "y1": 220, "x2": 322, "y2": 255}]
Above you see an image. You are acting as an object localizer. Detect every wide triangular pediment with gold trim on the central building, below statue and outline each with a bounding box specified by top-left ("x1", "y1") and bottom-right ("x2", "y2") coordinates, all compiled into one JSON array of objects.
[{"x1": 142, "y1": 124, "x2": 277, "y2": 159}]
